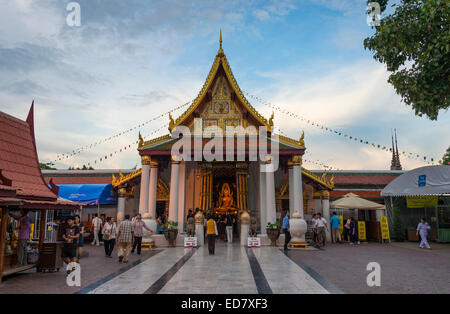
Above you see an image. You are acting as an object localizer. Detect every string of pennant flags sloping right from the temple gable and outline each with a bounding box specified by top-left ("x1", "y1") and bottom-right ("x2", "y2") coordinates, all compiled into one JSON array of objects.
[{"x1": 244, "y1": 91, "x2": 435, "y2": 164}]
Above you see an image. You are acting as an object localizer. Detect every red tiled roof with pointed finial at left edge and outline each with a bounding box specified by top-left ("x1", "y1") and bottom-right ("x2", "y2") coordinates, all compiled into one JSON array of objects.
[{"x1": 0, "y1": 104, "x2": 57, "y2": 201}]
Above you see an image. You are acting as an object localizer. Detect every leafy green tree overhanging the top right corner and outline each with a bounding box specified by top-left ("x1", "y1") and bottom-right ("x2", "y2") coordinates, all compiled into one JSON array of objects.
[{"x1": 364, "y1": 0, "x2": 450, "y2": 120}]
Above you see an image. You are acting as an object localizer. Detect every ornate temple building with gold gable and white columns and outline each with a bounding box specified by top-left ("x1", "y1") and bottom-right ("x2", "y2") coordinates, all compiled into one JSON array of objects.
[{"x1": 112, "y1": 38, "x2": 334, "y2": 240}]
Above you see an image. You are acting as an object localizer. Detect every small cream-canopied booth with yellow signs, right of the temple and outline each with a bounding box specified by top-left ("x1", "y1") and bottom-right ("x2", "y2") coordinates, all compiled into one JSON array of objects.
[{"x1": 330, "y1": 193, "x2": 389, "y2": 242}]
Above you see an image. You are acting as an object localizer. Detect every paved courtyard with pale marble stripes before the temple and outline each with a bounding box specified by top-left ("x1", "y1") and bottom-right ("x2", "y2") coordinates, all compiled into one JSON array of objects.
[{"x1": 0, "y1": 243, "x2": 450, "y2": 294}]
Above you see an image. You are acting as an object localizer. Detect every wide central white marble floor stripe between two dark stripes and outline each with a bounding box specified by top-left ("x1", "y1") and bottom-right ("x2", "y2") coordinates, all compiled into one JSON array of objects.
[{"x1": 159, "y1": 243, "x2": 258, "y2": 294}]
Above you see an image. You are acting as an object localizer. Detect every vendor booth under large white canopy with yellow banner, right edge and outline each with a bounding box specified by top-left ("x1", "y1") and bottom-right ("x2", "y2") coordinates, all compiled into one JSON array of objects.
[{"x1": 381, "y1": 165, "x2": 450, "y2": 242}]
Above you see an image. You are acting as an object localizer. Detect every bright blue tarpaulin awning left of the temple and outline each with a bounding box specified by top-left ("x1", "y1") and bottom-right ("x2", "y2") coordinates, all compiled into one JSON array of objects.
[{"x1": 58, "y1": 184, "x2": 116, "y2": 205}]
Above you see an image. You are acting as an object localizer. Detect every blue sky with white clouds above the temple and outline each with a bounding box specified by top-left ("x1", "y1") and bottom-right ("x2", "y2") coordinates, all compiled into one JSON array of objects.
[{"x1": 0, "y1": 0, "x2": 450, "y2": 170}]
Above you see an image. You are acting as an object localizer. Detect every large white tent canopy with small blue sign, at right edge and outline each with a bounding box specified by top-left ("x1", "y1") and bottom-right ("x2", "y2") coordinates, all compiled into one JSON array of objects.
[{"x1": 381, "y1": 166, "x2": 450, "y2": 196}]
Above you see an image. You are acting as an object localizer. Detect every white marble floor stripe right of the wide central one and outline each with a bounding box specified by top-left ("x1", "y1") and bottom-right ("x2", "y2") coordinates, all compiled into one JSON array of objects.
[{"x1": 252, "y1": 247, "x2": 329, "y2": 294}]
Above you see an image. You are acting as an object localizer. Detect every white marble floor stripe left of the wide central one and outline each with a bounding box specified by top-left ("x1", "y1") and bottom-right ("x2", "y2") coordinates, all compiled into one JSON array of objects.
[{"x1": 89, "y1": 248, "x2": 191, "y2": 294}]
